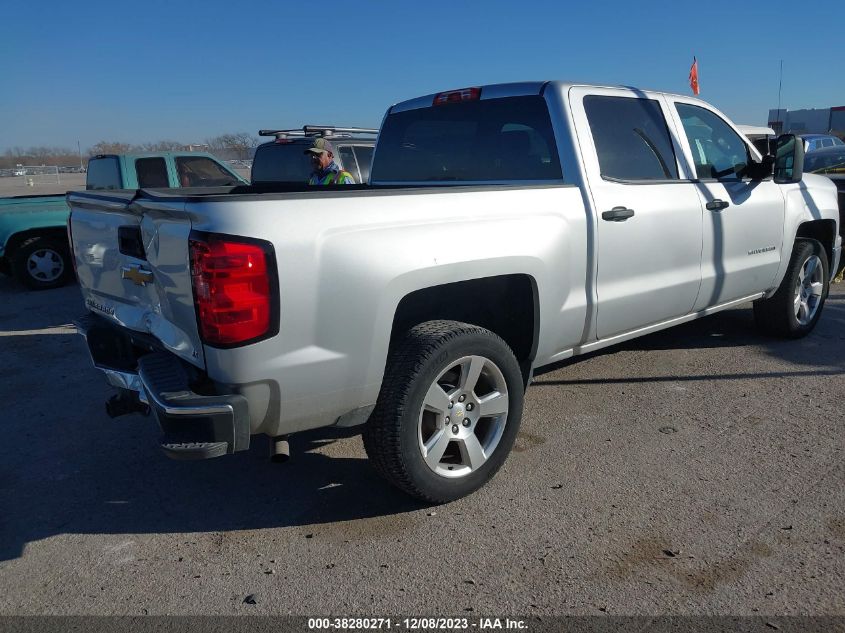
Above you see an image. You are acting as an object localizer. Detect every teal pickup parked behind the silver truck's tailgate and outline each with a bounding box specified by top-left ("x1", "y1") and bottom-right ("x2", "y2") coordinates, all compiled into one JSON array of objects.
[{"x1": 0, "y1": 152, "x2": 247, "y2": 290}]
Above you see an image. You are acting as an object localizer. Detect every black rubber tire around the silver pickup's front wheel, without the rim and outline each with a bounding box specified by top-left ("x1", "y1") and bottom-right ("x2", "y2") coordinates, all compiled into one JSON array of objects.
[{"x1": 754, "y1": 238, "x2": 830, "y2": 338}]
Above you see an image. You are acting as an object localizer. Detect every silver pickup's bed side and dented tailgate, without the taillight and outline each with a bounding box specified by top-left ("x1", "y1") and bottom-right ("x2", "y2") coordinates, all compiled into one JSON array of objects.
[{"x1": 69, "y1": 184, "x2": 588, "y2": 435}]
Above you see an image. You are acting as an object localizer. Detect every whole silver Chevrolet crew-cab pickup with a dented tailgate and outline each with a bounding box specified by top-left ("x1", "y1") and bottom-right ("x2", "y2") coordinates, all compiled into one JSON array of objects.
[{"x1": 68, "y1": 82, "x2": 841, "y2": 502}]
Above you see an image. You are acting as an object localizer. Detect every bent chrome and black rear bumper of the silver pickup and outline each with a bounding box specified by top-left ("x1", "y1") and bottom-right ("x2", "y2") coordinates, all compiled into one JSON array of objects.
[{"x1": 75, "y1": 315, "x2": 250, "y2": 459}]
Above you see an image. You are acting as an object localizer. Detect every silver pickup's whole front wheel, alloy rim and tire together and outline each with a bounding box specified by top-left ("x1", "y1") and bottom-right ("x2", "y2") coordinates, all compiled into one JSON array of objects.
[{"x1": 754, "y1": 239, "x2": 830, "y2": 338}]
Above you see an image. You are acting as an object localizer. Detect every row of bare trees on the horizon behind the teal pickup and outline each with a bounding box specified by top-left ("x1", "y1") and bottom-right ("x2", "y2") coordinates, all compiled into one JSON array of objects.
[{"x1": 0, "y1": 132, "x2": 261, "y2": 169}]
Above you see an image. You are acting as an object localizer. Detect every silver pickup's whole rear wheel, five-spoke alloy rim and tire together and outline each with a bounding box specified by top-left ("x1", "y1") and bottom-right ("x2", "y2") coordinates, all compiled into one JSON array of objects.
[{"x1": 364, "y1": 321, "x2": 524, "y2": 503}]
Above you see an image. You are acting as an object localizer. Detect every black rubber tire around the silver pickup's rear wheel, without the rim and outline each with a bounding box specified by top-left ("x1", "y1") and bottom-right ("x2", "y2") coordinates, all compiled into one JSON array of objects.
[{"x1": 363, "y1": 321, "x2": 524, "y2": 503}]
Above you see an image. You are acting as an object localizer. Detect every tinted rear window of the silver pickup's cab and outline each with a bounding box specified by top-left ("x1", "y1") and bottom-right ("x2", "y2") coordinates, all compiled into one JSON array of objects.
[{"x1": 370, "y1": 95, "x2": 563, "y2": 183}]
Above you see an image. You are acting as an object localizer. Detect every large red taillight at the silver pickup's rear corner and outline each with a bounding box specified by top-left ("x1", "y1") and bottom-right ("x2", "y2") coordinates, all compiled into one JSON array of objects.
[{"x1": 190, "y1": 235, "x2": 275, "y2": 347}]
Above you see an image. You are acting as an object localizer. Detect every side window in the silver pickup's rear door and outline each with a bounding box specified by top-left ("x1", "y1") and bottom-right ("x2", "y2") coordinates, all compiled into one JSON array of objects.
[{"x1": 584, "y1": 95, "x2": 678, "y2": 181}]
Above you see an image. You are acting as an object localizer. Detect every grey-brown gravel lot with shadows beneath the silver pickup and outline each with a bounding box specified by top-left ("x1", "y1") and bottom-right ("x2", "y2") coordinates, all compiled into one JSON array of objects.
[{"x1": 0, "y1": 278, "x2": 845, "y2": 616}]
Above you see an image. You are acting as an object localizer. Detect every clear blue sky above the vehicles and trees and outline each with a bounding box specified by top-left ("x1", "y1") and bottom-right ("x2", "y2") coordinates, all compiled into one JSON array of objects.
[{"x1": 0, "y1": 0, "x2": 845, "y2": 152}]
